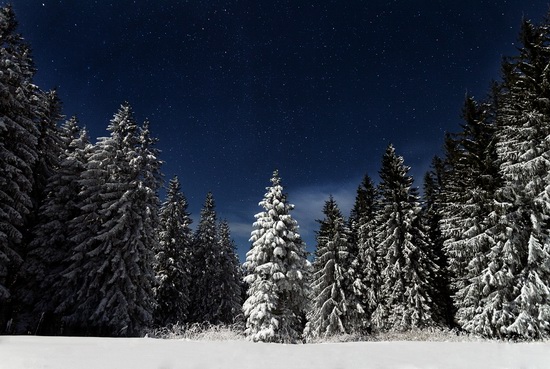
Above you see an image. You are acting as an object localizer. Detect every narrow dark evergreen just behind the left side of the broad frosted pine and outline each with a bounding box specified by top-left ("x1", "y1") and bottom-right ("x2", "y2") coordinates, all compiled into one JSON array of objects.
[{"x1": 17, "y1": 117, "x2": 89, "y2": 334}]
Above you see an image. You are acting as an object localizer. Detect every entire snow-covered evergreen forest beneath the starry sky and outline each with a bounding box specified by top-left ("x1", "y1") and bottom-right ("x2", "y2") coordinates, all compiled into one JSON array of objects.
[{"x1": 0, "y1": 2, "x2": 550, "y2": 343}]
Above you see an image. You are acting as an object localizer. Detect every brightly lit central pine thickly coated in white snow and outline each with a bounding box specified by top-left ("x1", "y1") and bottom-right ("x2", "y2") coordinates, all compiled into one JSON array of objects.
[{"x1": 243, "y1": 171, "x2": 309, "y2": 342}]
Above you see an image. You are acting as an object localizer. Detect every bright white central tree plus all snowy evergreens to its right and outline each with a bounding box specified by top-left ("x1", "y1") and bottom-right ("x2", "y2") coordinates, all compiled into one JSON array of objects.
[{"x1": 244, "y1": 14, "x2": 550, "y2": 342}]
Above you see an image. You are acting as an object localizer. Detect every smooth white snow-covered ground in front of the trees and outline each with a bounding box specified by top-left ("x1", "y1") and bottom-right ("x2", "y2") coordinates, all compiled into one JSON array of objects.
[{"x1": 0, "y1": 336, "x2": 550, "y2": 369}]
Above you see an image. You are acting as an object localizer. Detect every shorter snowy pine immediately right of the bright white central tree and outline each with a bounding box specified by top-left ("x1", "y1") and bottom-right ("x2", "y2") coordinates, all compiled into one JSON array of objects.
[{"x1": 306, "y1": 196, "x2": 363, "y2": 338}]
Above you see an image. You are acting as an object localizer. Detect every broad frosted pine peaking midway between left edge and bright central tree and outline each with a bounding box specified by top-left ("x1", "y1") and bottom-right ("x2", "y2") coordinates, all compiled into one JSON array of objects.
[{"x1": 57, "y1": 104, "x2": 160, "y2": 335}]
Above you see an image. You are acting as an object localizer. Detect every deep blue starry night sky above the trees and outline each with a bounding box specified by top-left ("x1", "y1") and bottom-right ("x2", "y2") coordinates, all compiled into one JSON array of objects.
[{"x1": 12, "y1": 0, "x2": 549, "y2": 258}]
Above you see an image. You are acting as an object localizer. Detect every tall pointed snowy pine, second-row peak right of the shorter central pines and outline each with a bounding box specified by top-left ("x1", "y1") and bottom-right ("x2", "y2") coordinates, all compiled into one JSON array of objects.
[{"x1": 372, "y1": 145, "x2": 440, "y2": 331}]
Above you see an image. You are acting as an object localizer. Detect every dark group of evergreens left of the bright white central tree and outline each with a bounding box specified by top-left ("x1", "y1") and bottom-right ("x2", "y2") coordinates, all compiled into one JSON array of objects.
[{"x1": 0, "y1": 6, "x2": 242, "y2": 336}]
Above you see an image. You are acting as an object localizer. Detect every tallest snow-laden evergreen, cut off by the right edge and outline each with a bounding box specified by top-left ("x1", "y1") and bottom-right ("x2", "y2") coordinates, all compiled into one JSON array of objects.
[{"x1": 469, "y1": 20, "x2": 550, "y2": 338}]
